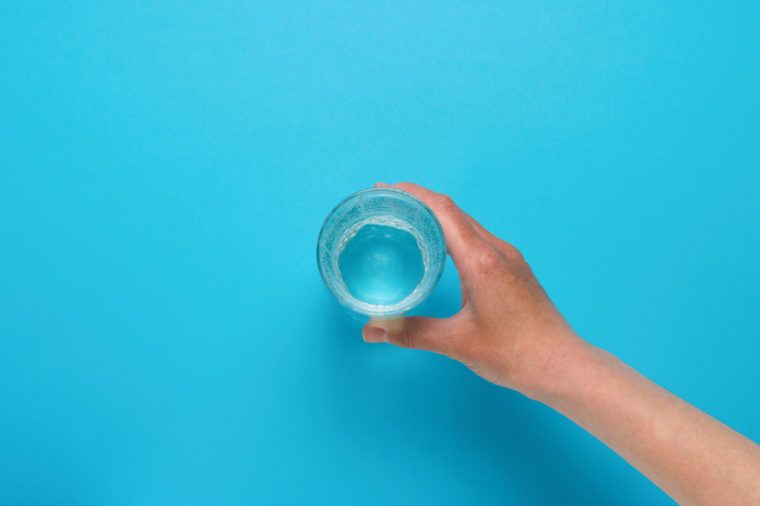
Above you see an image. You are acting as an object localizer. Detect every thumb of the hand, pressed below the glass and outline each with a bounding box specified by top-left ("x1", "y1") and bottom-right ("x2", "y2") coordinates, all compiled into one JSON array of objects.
[{"x1": 362, "y1": 316, "x2": 453, "y2": 352}]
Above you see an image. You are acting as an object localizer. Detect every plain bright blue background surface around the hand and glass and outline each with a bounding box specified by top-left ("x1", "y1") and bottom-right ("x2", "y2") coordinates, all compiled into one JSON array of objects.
[{"x1": 0, "y1": 0, "x2": 760, "y2": 505}]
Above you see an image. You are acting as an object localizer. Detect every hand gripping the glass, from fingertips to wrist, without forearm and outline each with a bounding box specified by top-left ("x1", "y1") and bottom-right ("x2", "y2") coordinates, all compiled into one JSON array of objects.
[{"x1": 362, "y1": 183, "x2": 583, "y2": 397}]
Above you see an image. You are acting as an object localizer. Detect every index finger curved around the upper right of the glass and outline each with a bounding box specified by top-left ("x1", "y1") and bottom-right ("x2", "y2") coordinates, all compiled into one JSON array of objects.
[{"x1": 375, "y1": 183, "x2": 485, "y2": 271}]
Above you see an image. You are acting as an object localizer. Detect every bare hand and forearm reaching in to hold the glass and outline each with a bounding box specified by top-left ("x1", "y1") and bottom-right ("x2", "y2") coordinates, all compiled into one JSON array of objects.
[{"x1": 362, "y1": 183, "x2": 760, "y2": 505}]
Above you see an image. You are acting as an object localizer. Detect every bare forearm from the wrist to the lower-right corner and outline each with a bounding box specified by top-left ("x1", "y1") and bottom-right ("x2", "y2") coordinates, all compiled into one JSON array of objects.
[{"x1": 532, "y1": 341, "x2": 760, "y2": 504}]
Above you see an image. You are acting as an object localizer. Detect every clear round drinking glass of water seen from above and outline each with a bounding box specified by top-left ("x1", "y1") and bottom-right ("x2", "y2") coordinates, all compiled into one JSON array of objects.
[{"x1": 317, "y1": 188, "x2": 446, "y2": 318}]
